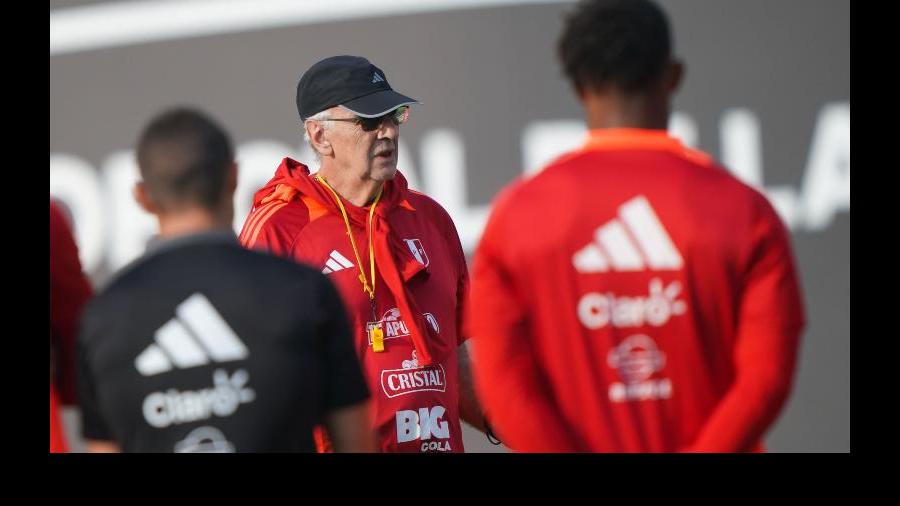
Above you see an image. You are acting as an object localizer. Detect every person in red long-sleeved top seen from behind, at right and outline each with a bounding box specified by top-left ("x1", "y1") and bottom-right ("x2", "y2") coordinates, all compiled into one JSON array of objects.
[{"x1": 469, "y1": 0, "x2": 804, "y2": 452}]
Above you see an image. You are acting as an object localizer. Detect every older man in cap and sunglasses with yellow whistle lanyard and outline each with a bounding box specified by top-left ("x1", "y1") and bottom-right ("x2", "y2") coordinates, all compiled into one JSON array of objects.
[{"x1": 240, "y1": 56, "x2": 484, "y2": 452}]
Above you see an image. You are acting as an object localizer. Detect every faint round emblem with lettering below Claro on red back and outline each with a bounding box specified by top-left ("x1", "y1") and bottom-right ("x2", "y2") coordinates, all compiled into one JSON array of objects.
[{"x1": 607, "y1": 334, "x2": 672, "y2": 402}]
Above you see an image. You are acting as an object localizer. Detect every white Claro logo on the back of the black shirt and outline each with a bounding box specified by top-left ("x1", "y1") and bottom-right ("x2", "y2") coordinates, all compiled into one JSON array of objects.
[{"x1": 143, "y1": 369, "x2": 256, "y2": 429}]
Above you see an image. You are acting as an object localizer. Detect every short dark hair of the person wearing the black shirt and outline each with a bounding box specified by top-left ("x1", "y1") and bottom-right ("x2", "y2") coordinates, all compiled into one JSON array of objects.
[{"x1": 137, "y1": 107, "x2": 234, "y2": 211}]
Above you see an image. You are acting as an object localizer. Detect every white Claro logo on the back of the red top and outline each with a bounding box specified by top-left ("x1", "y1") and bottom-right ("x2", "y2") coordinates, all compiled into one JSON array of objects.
[{"x1": 578, "y1": 278, "x2": 687, "y2": 330}]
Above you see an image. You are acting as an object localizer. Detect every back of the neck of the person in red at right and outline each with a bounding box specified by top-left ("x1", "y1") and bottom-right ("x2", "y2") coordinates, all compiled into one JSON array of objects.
[{"x1": 581, "y1": 90, "x2": 669, "y2": 130}]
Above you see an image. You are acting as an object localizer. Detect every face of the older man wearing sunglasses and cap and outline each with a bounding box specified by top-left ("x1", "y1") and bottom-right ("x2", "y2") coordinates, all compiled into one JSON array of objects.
[{"x1": 325, "y1": 106, "x2": 400, "y2": 181}]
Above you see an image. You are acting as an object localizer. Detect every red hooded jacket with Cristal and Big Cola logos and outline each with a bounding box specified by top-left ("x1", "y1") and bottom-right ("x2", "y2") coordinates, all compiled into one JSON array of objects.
[{"x1": 240, "y1": 158, "x2": 468, "y2": 452}]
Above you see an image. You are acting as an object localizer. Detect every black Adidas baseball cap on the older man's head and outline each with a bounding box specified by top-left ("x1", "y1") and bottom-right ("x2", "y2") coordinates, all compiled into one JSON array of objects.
[{"x1": 297, "y1": 55, "x2": 419, "y2": 120}]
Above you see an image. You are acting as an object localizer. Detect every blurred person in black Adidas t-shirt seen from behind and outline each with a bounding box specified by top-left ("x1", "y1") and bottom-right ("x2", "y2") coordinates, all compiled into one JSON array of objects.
[{"x1": 78, "y1": 105, "x2": 374, "y2": 453}]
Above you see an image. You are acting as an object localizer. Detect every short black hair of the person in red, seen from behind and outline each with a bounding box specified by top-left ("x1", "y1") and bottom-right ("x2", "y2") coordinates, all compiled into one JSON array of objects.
[{"x1": 557, "y1": 0, "x2": 671, "y2": 93}]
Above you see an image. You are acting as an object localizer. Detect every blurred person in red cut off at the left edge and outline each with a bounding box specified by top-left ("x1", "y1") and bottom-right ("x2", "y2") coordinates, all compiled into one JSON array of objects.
[{"x1": 50, "y1": 200, "x2": 93, "y2": 453}]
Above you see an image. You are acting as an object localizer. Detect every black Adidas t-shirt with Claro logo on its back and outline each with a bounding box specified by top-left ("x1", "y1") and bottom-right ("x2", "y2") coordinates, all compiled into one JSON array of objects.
[{"x1": 78, "y1": 233, "x2": 369, "y2": 452}]
